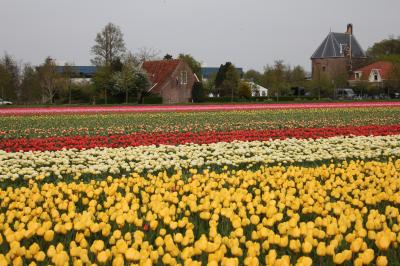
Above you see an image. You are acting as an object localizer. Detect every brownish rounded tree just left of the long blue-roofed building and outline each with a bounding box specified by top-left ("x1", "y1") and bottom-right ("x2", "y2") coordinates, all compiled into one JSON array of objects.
[{"x1": 38, "y1": 57, "x2": 60, "y2": 104}]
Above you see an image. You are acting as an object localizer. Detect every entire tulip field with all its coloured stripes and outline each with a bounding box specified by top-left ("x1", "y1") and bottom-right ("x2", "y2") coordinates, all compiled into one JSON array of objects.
[{"x1": 0, "y1": 102, "x2": 400, "y2": 266}]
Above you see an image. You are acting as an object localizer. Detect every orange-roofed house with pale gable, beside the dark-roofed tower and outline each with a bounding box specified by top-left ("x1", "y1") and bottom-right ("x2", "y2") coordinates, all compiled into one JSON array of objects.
[{"x1": 349, "y1": 61, "x2": 393, "y2": 85}]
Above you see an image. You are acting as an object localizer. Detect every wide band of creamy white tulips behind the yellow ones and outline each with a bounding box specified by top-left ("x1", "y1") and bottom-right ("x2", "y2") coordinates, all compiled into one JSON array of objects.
[{"x1": 0, "y1": 135, "x2": 400, "y2": 184}]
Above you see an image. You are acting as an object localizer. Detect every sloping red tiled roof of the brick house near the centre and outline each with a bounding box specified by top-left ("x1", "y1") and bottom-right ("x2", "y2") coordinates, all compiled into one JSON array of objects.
[{"x1": 142, "y1": 59, "x2": 181, "y2": 93}]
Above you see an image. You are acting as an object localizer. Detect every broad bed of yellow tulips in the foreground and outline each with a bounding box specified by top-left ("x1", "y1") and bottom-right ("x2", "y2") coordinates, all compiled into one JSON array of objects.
[{"x1": 0, "y1": 160, "x2": 400, "y2": 265}]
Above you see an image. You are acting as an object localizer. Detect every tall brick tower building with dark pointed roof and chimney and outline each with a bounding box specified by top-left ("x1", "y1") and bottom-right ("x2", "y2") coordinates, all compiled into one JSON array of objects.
[{"x1": 311, "y1": 24, "x2": 367, "y2": 80}]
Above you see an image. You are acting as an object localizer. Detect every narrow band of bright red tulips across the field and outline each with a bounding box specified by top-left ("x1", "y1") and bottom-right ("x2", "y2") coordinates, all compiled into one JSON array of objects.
[{"x1": 0, "y1": 125, "x2": 400, "y2": 152}]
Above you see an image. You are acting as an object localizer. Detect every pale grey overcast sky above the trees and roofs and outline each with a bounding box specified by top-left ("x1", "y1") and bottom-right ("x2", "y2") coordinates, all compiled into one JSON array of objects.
[{"x1": 0, "y1": 0, "x2": 400, "y2": 70}]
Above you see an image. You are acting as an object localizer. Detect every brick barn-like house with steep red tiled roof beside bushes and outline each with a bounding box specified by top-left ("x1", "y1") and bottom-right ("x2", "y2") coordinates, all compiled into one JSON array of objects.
[{"x1": 142, "y1": 59, "x2": 199, "y2": 104}]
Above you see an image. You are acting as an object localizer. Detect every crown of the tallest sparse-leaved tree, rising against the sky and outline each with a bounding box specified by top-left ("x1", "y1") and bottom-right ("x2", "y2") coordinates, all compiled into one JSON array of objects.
[{"x1": 91, "y1": 23, "x2": 125, "y2": 66}]
